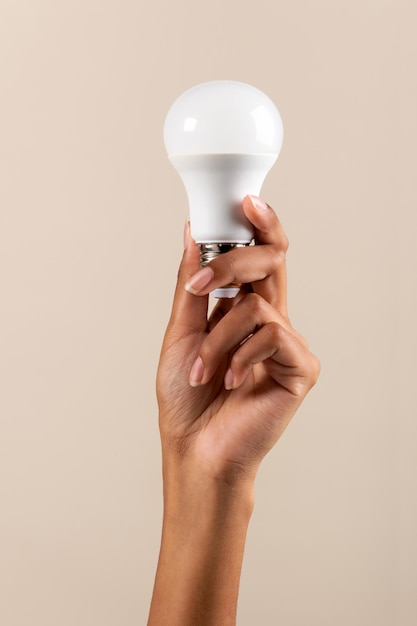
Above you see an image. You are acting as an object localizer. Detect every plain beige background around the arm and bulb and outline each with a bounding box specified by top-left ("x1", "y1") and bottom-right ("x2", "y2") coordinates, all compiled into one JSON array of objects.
[{"x1": 0, "y1": 0, "x2": 417, "y2": 626}]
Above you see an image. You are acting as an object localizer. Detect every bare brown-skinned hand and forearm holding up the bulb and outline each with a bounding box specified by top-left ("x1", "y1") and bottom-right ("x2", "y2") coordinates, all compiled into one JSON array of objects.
[{"x1": 148, "y1": 196, "x2": 320, "y2": 626}]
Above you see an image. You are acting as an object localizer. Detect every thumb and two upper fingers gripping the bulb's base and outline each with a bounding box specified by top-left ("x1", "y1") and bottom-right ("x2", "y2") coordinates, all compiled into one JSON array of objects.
[{"x1": 164, "y1": 196, "x2": 288, "y2": 342}]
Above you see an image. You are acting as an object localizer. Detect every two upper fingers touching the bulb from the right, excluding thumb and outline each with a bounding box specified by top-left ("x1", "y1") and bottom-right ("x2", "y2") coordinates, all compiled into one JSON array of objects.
[{"x1": 185, "y1": 196, "x2": 288, "y2": 316}]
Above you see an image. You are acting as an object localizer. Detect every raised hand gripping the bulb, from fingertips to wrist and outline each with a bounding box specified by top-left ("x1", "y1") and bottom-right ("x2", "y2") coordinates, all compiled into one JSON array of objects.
[{"x1": 157, "y1": 196, "x2": 319, "y2": 481}]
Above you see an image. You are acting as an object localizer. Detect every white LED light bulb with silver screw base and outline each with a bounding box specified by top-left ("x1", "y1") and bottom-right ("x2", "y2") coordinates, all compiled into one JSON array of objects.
[{"x1": 164, "y1": 80, "x2": 283, "y2": 298}]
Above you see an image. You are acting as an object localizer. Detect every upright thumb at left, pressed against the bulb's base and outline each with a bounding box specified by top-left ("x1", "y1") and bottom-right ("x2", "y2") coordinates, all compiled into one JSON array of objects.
[{"x1": 167, "y1": 222, "x2": 209, "y2": 339}]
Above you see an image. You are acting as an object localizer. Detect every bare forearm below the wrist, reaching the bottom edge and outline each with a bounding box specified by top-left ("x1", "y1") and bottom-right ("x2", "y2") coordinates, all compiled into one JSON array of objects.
[{"x1": 148, "y1": 459, "x2": 253, "y2": 626}]
